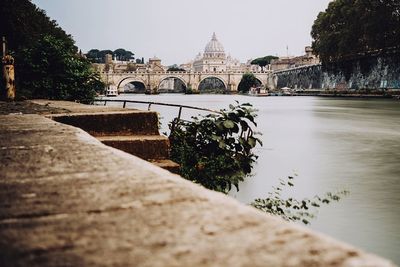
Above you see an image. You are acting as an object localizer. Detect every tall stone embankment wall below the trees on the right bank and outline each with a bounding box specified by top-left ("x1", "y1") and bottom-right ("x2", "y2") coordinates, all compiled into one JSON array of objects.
[{"x1": 274, "y1": 54, "x2": 400, "y2": 91}]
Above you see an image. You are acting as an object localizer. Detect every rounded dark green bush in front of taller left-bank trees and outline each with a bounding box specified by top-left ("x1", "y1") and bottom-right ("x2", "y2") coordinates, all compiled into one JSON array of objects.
[{"x1": 17, "y1": 35, "x2": 103, "y2": 101}]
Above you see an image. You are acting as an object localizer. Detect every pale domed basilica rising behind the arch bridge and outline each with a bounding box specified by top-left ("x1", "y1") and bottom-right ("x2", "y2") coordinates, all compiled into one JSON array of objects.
[{"x1": 181, "y1": 33, "x2": 245, "y2": 72}]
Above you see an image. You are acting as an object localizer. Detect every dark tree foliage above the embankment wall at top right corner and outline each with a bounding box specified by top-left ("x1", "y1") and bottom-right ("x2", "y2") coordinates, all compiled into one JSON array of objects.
[{"x1": 311, "y1": 0, "x2": 400, "y2": 63}]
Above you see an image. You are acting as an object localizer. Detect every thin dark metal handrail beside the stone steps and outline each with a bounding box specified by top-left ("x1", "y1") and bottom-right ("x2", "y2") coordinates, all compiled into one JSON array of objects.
[{"x1": 93, "y1": 99, "x2": 222, "y2": 132}]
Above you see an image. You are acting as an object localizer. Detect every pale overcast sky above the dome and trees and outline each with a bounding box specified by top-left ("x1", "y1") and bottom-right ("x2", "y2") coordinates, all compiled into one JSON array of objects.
[{"x1": 32, "y1": 0, "x2": 331, "y2": 65}]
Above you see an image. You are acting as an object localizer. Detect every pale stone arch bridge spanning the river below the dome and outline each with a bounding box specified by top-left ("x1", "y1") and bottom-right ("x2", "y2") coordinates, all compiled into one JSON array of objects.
[{"x1": 100, "y1": 71, "x2": 273, "y2": 92}]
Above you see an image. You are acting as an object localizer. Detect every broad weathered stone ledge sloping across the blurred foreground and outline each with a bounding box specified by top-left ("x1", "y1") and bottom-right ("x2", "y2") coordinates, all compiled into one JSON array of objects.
[{"x1": 0, "y1": 115, "x2": 394, "y2": 267}]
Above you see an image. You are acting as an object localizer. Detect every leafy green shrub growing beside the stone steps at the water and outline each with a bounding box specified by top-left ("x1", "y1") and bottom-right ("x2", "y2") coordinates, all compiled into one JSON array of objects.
[{"x1": 170, "y1": 103, "x2": 261, "y2": 193}]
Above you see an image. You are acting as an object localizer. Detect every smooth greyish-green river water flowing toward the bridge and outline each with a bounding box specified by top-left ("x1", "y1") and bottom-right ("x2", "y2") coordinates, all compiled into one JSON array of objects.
[{"x1": 103, "y1": 94, "x2": 400, "y2": 265}]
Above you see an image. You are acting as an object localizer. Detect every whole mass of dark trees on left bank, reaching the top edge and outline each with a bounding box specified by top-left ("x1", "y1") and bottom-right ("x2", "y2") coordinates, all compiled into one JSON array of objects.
[{"x1": 0, "y1": 0, "x2": 103, "y2": 101}]
